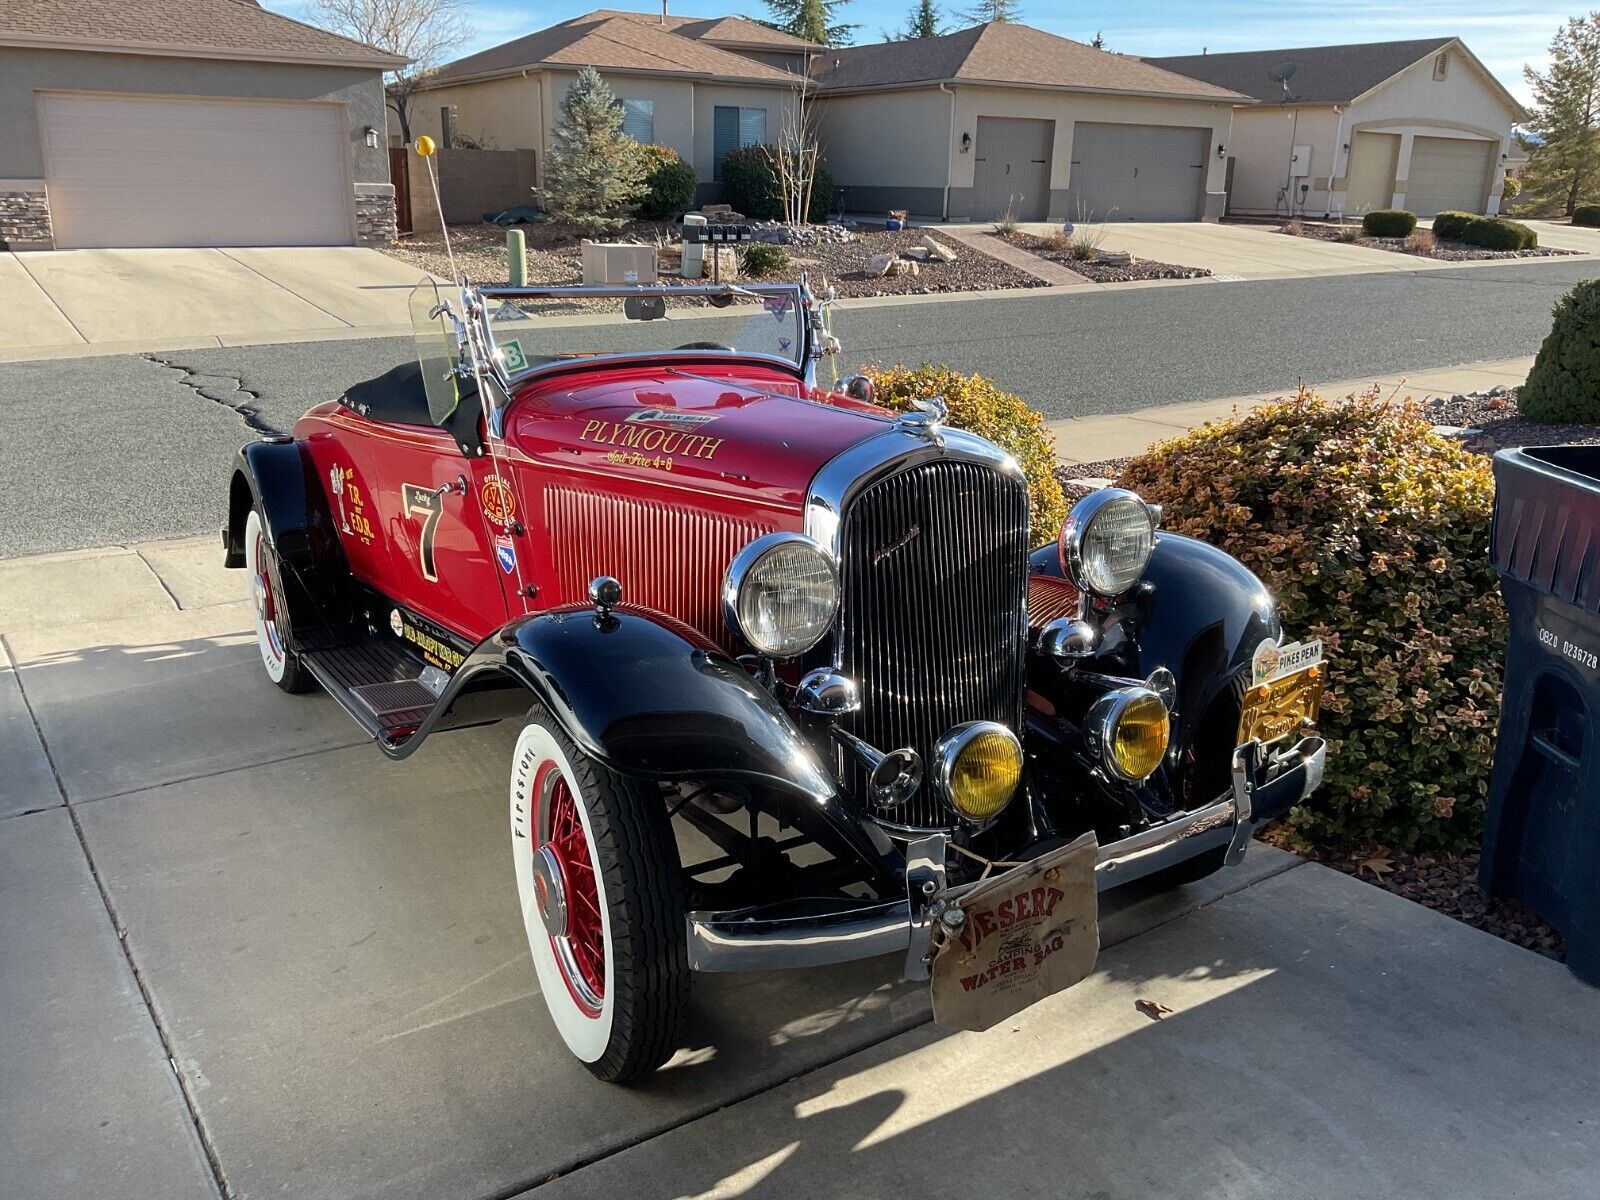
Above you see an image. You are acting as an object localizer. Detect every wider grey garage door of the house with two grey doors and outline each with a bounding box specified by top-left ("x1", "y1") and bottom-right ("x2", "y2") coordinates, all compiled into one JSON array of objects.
[{"x1": 1067, "y1": 122, "x2": 1211, "y2": 221}]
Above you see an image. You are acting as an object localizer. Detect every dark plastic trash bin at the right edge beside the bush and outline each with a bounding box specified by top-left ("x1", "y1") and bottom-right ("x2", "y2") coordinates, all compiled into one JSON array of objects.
[{"x1": 1478, "y1": 446, "x2": 1600, "y2": 984}]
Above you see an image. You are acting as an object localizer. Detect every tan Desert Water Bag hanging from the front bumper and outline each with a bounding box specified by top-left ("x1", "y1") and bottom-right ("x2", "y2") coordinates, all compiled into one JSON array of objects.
[{"x1": 928, "y1": 834, "x2": 1099, "y2": 1030}]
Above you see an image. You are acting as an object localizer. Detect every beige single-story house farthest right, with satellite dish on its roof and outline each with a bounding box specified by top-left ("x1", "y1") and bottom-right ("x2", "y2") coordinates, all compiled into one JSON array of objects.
[{"x1": 1146, "y1": 37, "x2": 1528, "y2": 216}]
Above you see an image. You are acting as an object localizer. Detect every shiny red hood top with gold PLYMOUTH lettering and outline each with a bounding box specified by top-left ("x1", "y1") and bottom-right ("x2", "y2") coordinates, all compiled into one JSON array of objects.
[{"x1": 506, "y1": 363, "x2": 890, "y2": 507}]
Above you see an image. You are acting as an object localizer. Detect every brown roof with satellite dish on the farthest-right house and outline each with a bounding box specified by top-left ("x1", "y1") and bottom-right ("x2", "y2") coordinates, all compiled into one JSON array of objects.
[{"x1": 1146, "y1": 37, "x2": 1456, "y2": 104}]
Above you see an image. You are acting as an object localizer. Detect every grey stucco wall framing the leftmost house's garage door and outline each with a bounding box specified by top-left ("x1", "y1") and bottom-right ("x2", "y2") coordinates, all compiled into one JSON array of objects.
[{"x1": 0, "y1": 46, "x2": 389, "y2": 184}]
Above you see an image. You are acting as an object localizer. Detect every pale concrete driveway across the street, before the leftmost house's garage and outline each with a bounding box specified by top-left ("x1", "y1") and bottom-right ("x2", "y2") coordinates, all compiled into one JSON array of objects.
[{"x1": 0, "y1": 246, "x2": 438, "y2": 362}]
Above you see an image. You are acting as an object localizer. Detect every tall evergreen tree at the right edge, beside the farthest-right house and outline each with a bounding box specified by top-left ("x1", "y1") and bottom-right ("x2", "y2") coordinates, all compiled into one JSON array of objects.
[{"x1": 1523, "y1": 13, "x2": 1600, "y2": 216}]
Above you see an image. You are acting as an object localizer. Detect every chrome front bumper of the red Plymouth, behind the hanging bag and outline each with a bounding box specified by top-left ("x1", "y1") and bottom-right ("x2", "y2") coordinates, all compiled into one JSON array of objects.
[{"x1": 686, "y1": 738, "x2": 1326, "y2": 979}]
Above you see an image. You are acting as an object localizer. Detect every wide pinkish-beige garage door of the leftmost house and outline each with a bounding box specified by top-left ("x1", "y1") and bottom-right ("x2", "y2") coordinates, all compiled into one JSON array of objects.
[{"x1": 38, "y1": 94, "x2": 355, "y2": 248}]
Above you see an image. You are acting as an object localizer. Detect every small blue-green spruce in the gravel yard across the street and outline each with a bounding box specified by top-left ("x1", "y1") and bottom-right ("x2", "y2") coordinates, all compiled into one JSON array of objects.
[{"x1": 539, "y1": 67, "x2": 645, "y2": 234}]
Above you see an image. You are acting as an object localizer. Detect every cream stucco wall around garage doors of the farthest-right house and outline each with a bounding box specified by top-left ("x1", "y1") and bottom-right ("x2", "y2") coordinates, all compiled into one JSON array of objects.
[{"x1": 1229, "y1": 51, "x2": 1515, "y2": 216}]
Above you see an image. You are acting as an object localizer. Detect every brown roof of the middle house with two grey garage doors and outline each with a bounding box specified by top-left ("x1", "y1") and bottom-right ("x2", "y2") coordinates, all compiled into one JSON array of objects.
[{"x1": 811, "y1": 22, "x2": 1245, "y2": 101}]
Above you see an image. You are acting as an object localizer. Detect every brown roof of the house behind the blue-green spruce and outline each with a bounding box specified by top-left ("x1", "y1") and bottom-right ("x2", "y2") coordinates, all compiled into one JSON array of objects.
[{"x1": 429, "y1": 10, "x2": 800, "y2": 86}]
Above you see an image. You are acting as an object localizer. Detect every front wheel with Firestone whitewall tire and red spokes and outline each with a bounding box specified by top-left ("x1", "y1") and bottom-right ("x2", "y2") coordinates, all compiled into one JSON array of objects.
[{"x1": 510, "y1": 709, "x2": 690, "y2": 1083}]
